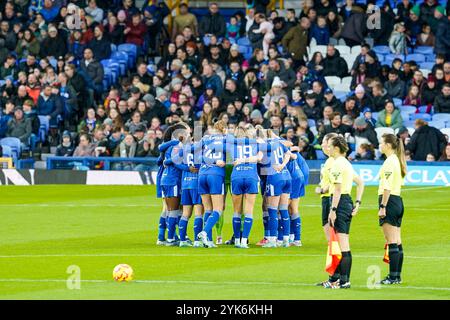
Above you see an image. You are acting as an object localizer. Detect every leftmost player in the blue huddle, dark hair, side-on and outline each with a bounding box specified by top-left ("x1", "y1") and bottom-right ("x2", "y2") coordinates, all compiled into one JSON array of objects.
[{"x1": 161, "y1": 124, "x2": 187, "y2": 246}]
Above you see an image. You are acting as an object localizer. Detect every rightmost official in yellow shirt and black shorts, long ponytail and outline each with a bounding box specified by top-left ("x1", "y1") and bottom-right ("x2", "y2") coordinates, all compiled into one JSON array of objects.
[{"x1": 378, "y1": 134, "x2": 406, "y2": 285}]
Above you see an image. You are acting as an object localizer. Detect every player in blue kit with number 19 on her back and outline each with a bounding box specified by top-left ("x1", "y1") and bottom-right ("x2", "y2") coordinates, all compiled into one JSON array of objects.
[{"x1": 229, "y1": 127, "x2": 263, "y2": 249}]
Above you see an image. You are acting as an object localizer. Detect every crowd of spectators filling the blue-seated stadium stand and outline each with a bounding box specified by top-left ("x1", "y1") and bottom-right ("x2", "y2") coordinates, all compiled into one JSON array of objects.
[{"x1": 0, "y1": 0, "x2": 450, "y2": 170}]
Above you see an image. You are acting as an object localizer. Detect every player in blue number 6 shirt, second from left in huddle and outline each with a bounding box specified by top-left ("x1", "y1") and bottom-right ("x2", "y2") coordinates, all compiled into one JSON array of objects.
[{"x1": 164, "y1": 138, "x2": 203, "y2": 247}]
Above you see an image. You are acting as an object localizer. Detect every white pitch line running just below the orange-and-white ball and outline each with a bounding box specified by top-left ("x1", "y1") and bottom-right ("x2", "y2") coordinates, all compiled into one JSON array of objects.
[{"x1": 0, "y1": 279, "x2": 450, "y2": 291}]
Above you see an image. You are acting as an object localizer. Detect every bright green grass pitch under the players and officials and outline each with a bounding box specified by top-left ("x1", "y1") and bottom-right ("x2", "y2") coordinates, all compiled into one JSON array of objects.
[{"x1": 0, "y1": 186, "x2": 450, "y2": 299}]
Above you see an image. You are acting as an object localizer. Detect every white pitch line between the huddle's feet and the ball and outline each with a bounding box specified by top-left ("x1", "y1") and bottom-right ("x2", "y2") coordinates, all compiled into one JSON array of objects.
[{"x1": 0, "y1": 254, "x2": 450, "y2": 261}]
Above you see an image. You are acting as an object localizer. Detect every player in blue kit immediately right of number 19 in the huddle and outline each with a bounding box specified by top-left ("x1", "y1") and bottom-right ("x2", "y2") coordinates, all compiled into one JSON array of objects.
[{"x1": 261, "y1": 130, "x2": 292, "y2": 248}]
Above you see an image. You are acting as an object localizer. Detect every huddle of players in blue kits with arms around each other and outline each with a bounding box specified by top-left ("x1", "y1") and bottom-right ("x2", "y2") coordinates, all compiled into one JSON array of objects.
[{"x1": 157, "y1": 121, "x2": 309, "y2": 248}]
